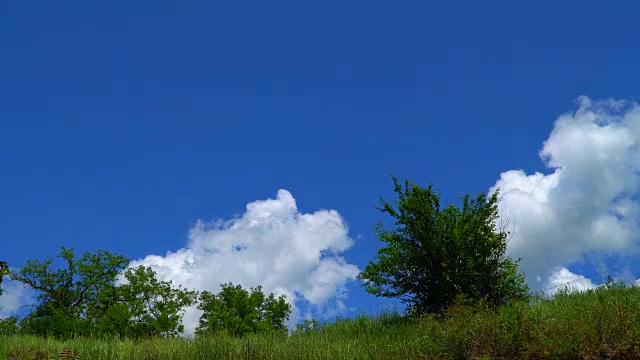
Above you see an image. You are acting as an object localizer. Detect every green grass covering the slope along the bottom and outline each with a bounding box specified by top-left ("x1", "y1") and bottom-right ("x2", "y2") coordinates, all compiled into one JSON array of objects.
[{"x1": 0, "y1": 286, "x2": 640, "y2": 360}]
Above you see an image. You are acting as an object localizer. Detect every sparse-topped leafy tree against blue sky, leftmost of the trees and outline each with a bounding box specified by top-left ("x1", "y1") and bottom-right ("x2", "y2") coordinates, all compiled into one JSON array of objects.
[{"x1": 11, "y1": 246, "x2": 129, "y2": 337}]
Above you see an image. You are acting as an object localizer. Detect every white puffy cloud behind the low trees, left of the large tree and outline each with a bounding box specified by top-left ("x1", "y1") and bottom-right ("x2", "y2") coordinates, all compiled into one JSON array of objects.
[{"x1": 129, "y1": 190, "x2": 359, "y2": 335}]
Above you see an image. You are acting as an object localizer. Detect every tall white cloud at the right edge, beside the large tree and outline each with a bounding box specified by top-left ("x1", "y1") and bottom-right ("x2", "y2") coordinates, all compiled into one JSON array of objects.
[{"x1": 489, "y1": 97, "x2": 640, "y2": 289}]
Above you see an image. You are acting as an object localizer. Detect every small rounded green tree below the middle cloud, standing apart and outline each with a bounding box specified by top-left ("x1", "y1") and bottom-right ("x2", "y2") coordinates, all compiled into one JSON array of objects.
[{"x1": 196, "y1": 283, "x2": 291, "y2": 336}]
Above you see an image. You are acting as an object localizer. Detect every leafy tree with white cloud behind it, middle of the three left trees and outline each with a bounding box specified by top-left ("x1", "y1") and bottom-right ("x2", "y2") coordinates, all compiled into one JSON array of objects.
[{"x1": 89, "y1": 265, "x2": 198, "y2": 338}]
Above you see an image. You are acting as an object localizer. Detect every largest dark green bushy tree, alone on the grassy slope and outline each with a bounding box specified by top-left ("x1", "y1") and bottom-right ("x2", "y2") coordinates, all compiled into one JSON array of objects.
[{"x1": 358, "y1": 176, "x2": 529, "y2": 315}]
